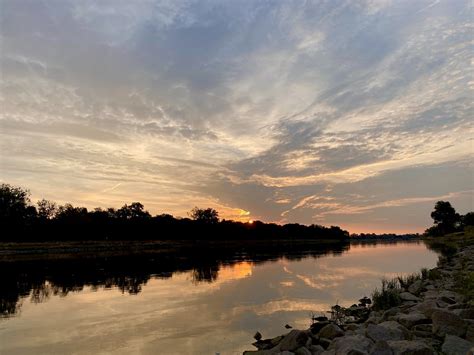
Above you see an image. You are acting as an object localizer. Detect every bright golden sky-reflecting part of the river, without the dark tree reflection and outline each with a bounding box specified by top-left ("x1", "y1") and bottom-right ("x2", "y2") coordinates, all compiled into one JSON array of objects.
[{"x1": 0, "y1": 243, "x2": 437, "y2": 354}]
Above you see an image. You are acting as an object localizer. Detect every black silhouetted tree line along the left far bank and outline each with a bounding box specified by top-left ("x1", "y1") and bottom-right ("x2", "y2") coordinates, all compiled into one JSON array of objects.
[{"x1": 0, "y1": 184, "x2": 349, "y2": 241}]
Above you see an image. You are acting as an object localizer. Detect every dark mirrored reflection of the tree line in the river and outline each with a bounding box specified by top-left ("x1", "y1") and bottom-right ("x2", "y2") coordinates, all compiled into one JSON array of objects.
[{"x1": 0, "y1": 242, "x2": 349, "y2": 317}]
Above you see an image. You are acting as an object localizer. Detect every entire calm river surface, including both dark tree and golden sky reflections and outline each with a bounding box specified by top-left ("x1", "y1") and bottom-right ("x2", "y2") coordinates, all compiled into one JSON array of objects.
[{"x1": 0, "y1": 243, "x2": 437, "y2": 354}]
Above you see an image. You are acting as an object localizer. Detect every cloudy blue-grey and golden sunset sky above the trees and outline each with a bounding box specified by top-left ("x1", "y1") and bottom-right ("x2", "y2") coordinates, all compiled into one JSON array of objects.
[{"x1": 0, "y1": 0, "x2": 474, "y2": 233}]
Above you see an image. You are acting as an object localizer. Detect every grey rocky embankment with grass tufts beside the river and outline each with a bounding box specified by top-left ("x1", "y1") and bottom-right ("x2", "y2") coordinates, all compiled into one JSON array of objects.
[{"x1": 244, "y1": 245, "x2": 474, "y2": 355}]
